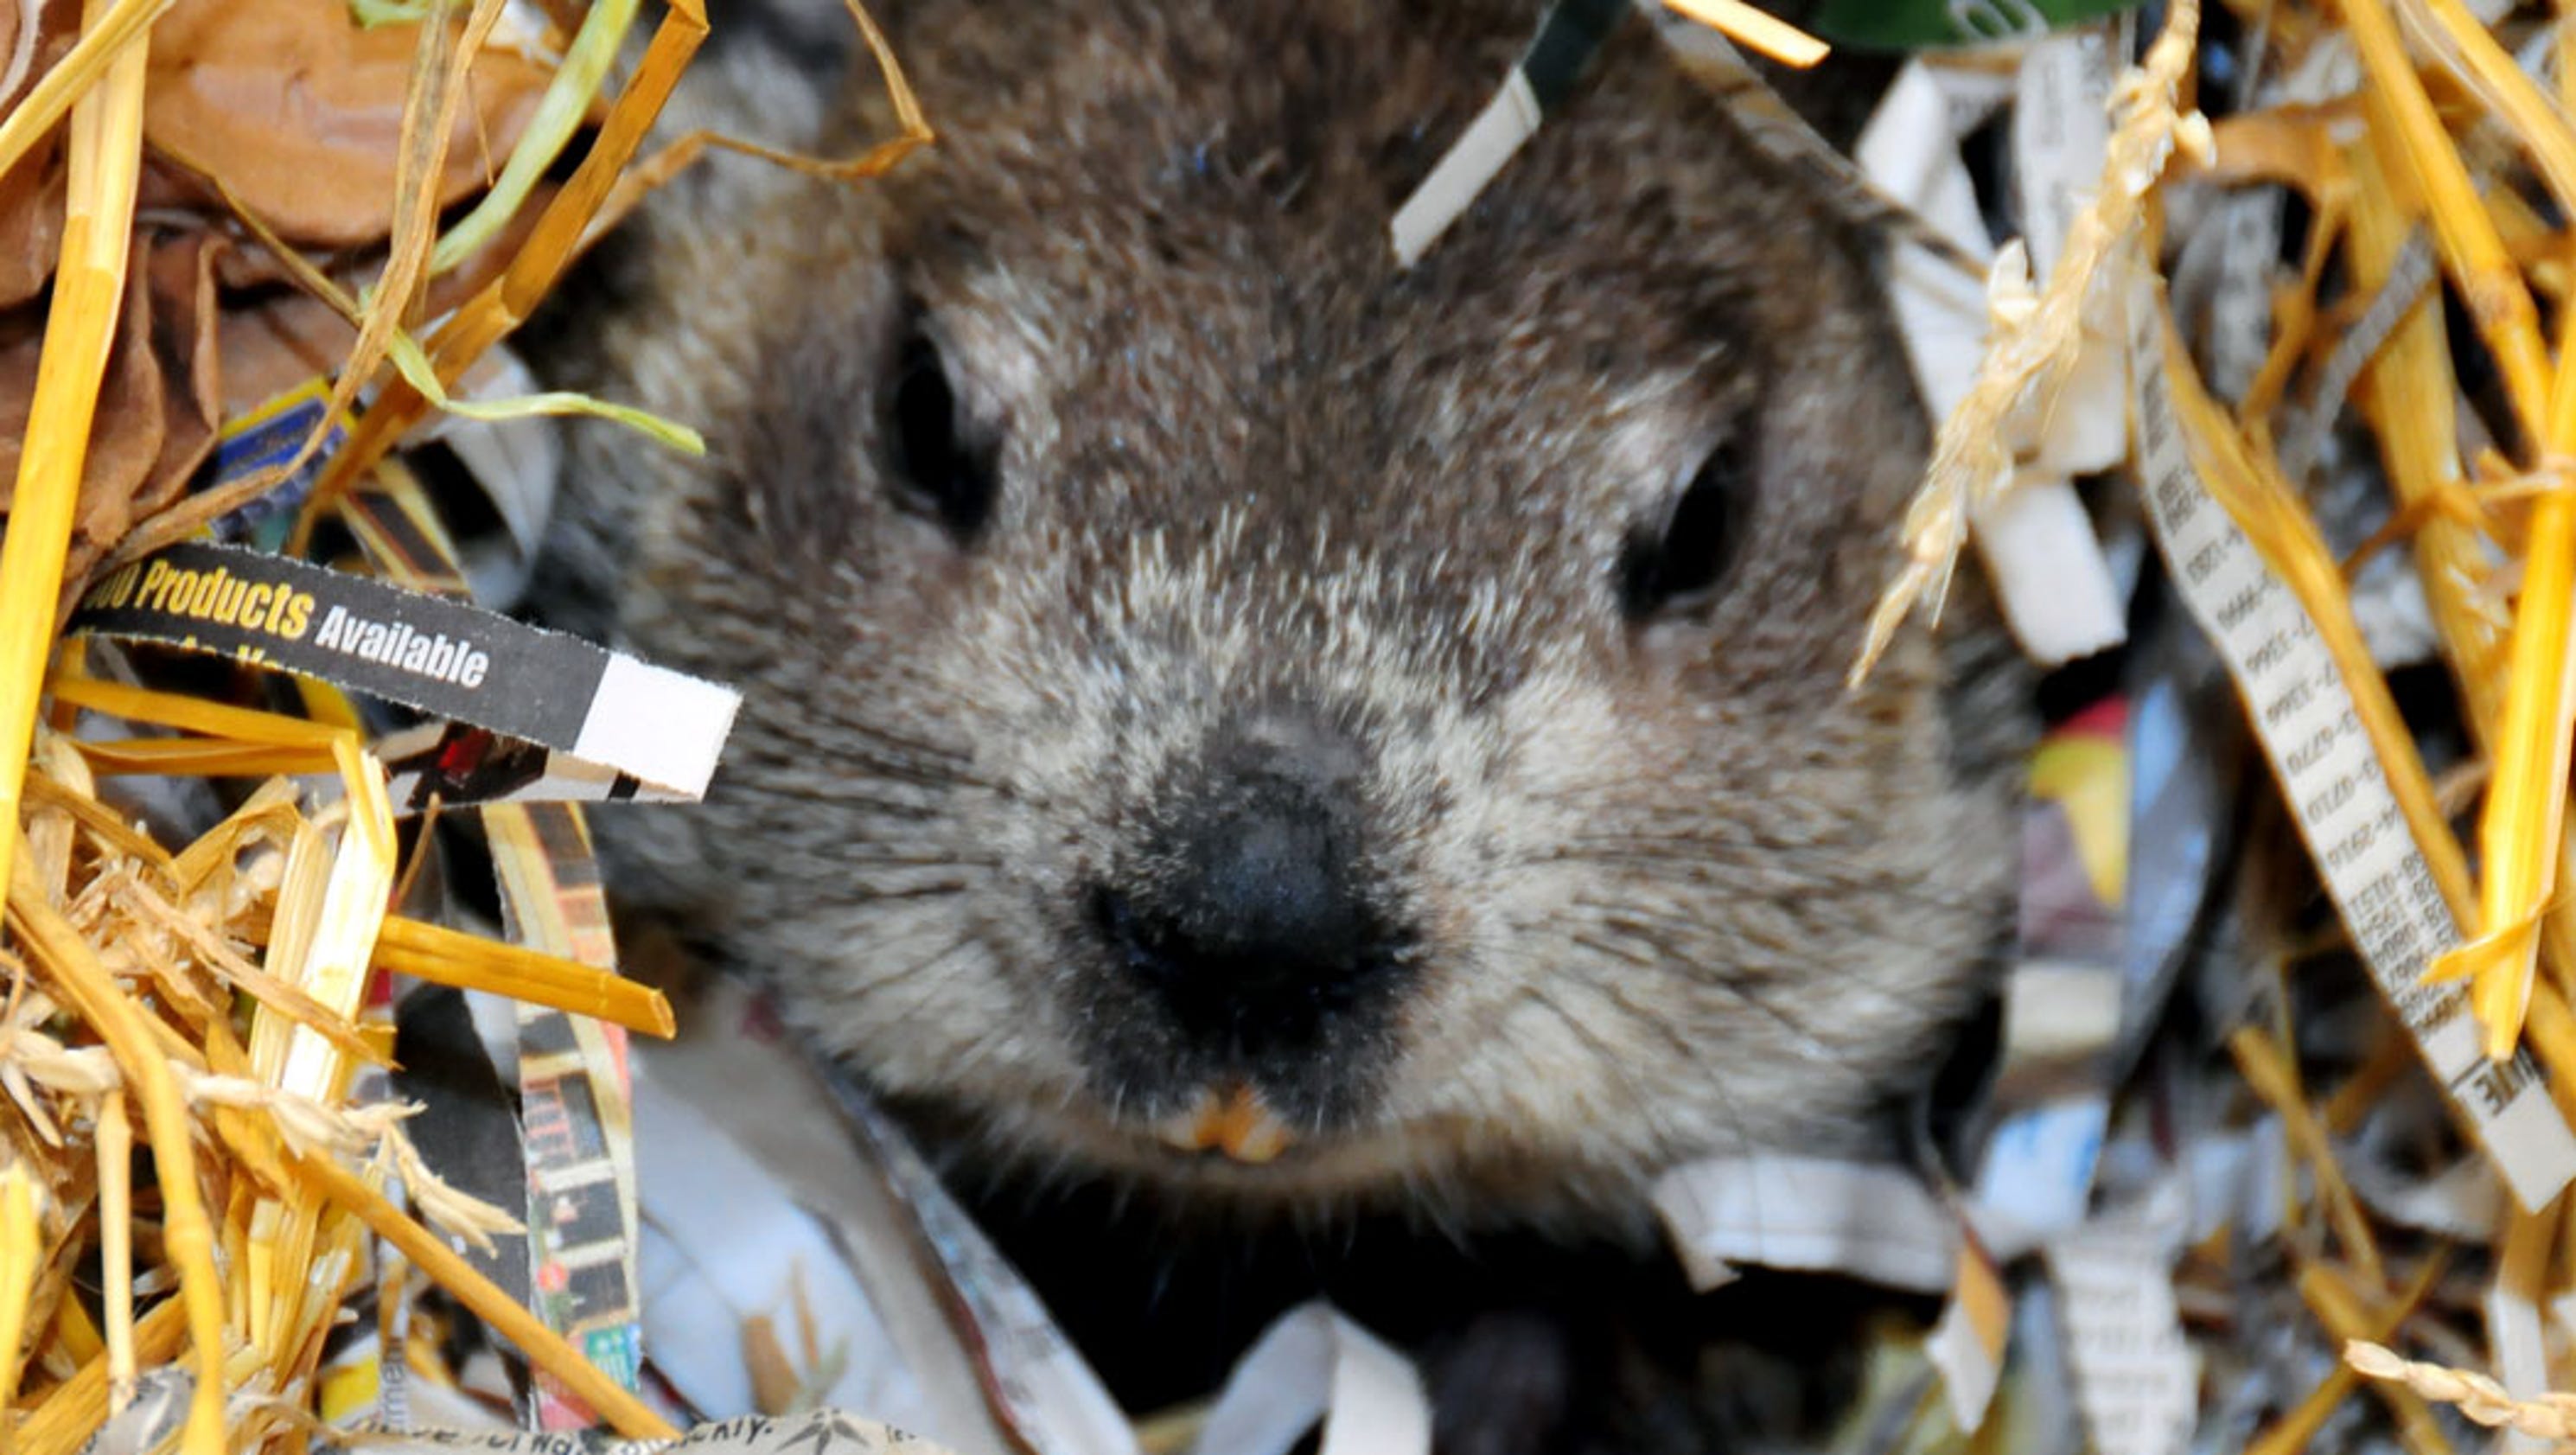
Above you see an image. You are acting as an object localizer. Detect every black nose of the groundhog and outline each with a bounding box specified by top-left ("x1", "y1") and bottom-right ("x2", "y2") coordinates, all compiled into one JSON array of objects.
[{"x1": 1095, "y1": 726, "x2": 1386, "y2": 1043}]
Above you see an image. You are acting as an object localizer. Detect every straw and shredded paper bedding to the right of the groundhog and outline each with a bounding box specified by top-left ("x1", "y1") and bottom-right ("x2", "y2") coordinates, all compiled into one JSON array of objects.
[{"x1": 1860, "y1": 0, "x2": 2576, "y2": 1452}]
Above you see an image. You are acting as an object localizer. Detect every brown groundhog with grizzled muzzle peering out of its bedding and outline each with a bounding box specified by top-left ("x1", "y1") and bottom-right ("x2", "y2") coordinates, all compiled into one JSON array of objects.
[{"x1": 539, "y1": 0, "x2": 2024, "y2": 1450}]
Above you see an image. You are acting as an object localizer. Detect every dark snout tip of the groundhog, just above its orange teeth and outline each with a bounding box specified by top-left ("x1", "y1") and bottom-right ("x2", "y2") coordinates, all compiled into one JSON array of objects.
[{"x1": 1090, "y1": 716, "x2": 1404, "y2": 1050}]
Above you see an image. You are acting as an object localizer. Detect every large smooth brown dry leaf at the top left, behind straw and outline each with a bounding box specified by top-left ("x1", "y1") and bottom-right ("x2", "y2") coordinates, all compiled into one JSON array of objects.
[{"x1": 144, "y1": 0, "x2": 549, "y2": 247}]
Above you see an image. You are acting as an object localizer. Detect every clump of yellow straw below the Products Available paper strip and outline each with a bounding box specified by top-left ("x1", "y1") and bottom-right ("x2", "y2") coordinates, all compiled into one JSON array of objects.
[{"x1": 0, "y1": 680, "x2": 667, "y2": 1450}]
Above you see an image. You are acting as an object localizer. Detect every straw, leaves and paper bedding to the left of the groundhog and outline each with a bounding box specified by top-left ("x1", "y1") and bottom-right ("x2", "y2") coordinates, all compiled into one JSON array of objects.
[{"x1": 0, "y1": 0, "x2": 928, "y2": 1455}]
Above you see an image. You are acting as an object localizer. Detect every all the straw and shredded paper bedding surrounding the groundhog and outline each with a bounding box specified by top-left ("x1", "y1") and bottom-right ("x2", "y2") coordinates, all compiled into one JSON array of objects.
[{"x1": 35, "y1": 0, "x2": 2576, "y2": 1455}]
